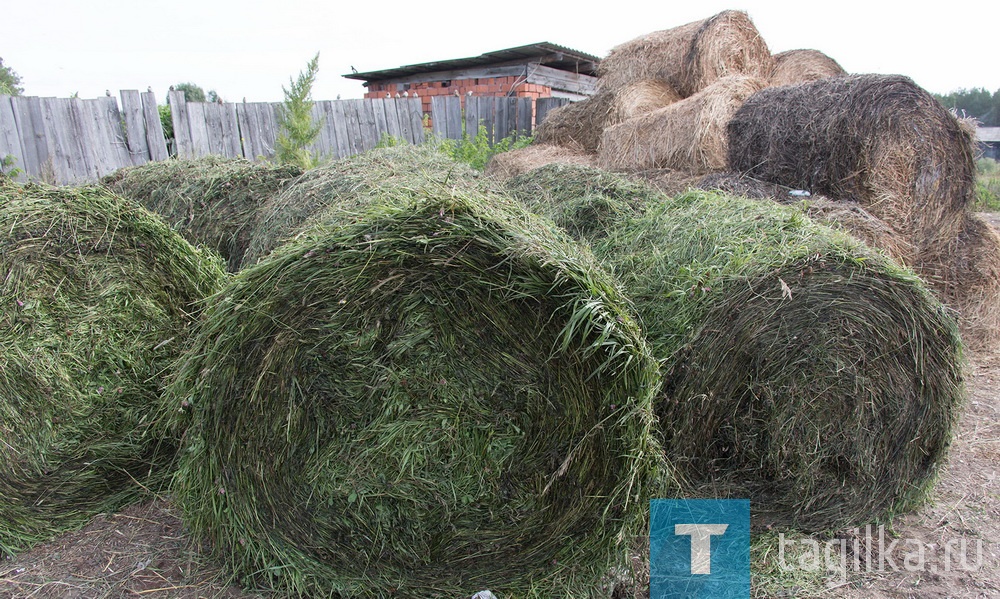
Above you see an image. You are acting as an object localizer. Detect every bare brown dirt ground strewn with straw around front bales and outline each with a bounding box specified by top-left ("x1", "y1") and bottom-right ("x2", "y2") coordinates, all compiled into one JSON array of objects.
[{"x1": 0, "y1": 220, "x2": 1000, "y2": 599}]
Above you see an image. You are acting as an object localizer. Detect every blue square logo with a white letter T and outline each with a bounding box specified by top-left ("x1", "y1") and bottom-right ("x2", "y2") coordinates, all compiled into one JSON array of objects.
[{"x1": 649, "y1": 499, "x2": 750, "y2": 599}]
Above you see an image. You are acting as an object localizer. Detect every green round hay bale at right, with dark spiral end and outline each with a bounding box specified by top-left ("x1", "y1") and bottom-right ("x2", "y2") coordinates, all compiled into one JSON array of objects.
[{"x1": 511, "y1": 167, "x2": 963, "y2": 530}]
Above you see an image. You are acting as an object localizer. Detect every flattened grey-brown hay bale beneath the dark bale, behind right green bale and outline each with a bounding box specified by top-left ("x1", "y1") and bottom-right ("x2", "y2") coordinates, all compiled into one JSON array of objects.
[{"x1": 698, "y1": 173, "x2": 916, "y2": 266}]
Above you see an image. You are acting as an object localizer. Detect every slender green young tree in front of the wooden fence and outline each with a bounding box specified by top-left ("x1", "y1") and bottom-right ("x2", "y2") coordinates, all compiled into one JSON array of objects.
[{"x1": 275, "y1": 52, "x2": 322, "y2": 169}]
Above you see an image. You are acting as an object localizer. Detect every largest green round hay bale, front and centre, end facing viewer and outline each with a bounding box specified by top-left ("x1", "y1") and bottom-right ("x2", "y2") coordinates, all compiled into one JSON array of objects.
[{"x1": 172, "y1": 151, "x2": 666, "y2": 597}]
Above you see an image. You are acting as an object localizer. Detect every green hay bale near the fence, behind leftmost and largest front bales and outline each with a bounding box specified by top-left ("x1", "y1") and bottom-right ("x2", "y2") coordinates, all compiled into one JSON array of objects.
[{"x1": 102, "y1": 156, "x2": 302, "y2": 272}]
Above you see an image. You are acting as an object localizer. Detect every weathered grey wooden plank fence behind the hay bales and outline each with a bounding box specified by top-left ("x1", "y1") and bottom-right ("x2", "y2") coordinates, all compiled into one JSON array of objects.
[{"x1": 0, "y1": 90, "x2": 568, "y2": 185}]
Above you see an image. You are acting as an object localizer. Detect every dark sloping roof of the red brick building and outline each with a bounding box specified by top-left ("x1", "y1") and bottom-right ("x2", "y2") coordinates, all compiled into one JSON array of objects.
[{"x1": 344, "y1": 42, "x2": 601, "y2": 81}]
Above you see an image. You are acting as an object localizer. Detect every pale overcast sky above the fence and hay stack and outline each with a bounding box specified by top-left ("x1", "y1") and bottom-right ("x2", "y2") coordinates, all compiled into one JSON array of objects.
[{"x1": 0, "y1": 0, "x2": 1000, "y2": 103}]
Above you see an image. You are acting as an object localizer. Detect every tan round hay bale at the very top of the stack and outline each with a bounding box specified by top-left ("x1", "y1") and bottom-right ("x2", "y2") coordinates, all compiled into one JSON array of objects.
[{"x1": 598, "y1": 10, "x2": 773, "y2": 98}]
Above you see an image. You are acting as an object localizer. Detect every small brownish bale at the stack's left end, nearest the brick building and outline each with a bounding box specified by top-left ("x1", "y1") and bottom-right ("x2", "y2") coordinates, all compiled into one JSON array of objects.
[{"x1": 535, "y1": 91, "x2": 615, "y2": 154}]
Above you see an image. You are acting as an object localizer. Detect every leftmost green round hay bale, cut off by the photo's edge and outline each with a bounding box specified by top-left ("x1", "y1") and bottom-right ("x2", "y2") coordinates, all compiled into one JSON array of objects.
[{"x1": 0, "y1": 181, "x2": 224, "y2": 554}]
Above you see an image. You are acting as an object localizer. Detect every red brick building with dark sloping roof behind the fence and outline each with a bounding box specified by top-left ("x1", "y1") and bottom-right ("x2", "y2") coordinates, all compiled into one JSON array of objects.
[{"x1": 344, "y1": 42, "x2": 600, "y2": 114}]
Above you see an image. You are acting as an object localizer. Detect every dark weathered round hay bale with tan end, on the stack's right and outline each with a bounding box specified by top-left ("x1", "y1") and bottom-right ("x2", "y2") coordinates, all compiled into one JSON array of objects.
[{"x1": 729, "y1": 75, "x2": 976, "y2": 252}]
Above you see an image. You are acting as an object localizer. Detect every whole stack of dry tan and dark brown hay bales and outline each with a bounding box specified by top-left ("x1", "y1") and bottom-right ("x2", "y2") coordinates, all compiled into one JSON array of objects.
[{"x1": 488, "y1": 11, "x2": 1000, "y2": 348}]
